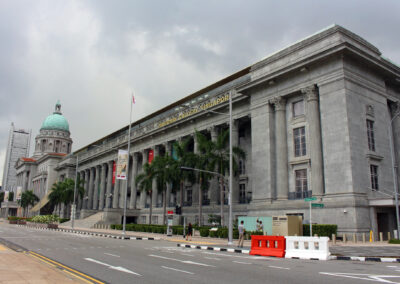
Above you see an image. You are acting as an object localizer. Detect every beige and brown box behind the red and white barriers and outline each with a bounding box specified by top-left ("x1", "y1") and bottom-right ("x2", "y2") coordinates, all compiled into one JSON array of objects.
[{"x1": 272, "y1": 216, "x2": 303, "y2": 236}]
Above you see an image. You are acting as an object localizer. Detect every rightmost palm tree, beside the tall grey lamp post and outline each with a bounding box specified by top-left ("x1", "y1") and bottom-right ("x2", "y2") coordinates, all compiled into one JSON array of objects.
[{"x1": 196, "y1": 130, "x2": 246, "y2": 226}]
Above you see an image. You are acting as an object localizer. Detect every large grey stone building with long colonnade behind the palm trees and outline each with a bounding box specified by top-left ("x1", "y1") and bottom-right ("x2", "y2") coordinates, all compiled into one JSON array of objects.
[{"x1": 18, "y1": 25, "x2": 400, "y2": 236}]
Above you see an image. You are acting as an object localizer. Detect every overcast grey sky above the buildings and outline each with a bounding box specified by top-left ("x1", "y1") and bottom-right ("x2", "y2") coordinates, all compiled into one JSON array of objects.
[{"x1": 0, "y1": 0, "x2": 400, "y2": 184}]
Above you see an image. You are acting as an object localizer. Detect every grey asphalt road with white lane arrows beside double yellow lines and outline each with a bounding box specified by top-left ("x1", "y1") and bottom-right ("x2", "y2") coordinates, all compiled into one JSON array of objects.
[{"x1": 0, "y1": 224, "x2": 400, "y2": 284}]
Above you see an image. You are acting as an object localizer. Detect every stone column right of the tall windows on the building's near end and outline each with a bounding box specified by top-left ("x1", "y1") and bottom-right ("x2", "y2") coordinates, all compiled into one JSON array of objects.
[{"x1": 301, "y1": 86, "x2": 324, "y2": 195}]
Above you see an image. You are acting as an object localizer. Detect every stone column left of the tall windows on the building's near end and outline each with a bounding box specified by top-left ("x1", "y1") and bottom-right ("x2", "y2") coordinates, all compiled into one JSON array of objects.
[{"x1": 271, "y1": 97, "x2": 289, "y2": 200}]
